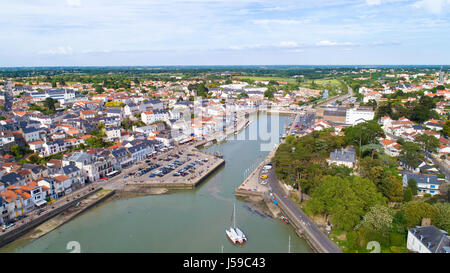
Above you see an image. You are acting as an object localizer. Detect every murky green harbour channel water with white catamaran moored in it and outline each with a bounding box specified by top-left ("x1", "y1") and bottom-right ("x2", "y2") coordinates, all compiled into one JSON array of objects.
[{"x1": 0, "y1": 111, "x2": 312, "y2": 253}]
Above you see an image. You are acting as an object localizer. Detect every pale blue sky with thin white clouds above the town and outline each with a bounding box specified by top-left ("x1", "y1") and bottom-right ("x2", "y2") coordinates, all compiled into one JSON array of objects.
[{"x1": 0, "y1": 0, "x2": 450, "y2": 67}]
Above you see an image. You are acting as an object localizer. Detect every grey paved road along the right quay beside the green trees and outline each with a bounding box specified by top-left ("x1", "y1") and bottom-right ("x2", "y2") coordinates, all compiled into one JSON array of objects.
[{"x1": 267, "y1": 168, "x2": 342, "y2": 253}]
